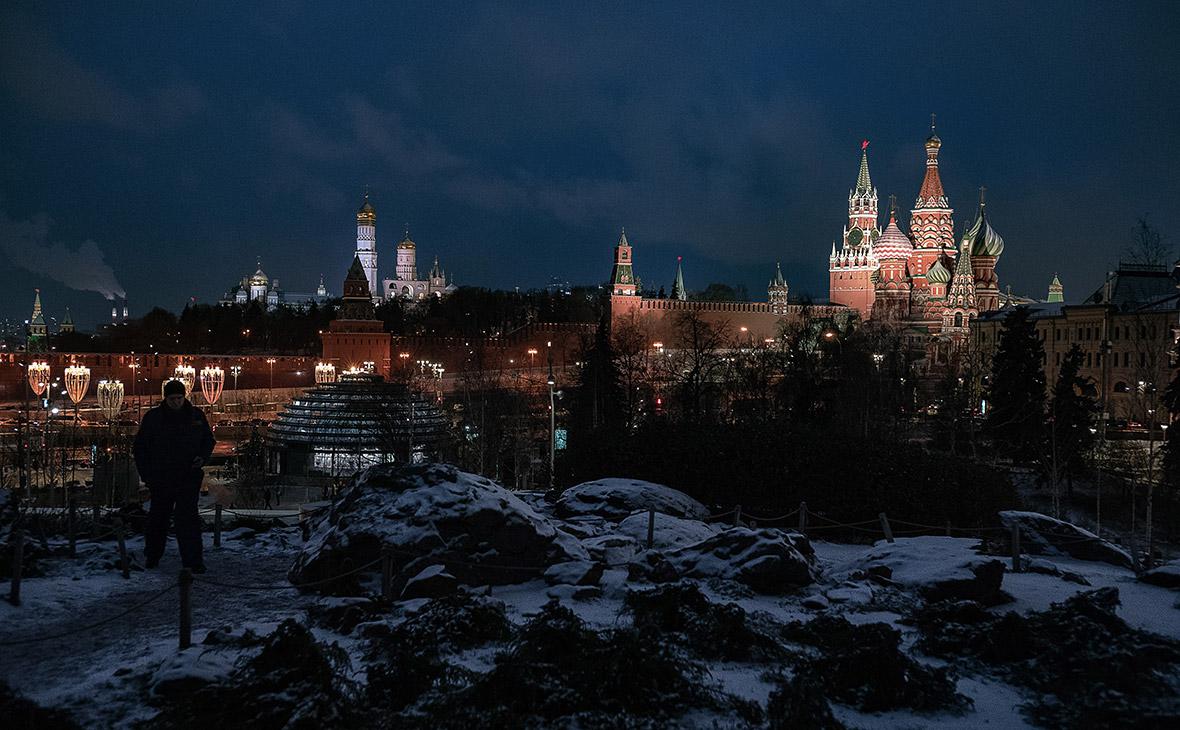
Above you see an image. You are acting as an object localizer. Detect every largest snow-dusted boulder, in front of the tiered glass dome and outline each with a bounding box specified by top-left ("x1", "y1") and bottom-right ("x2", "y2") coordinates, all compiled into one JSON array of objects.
[{"x1": 289, "y1": 463, "x2": 589, "y2": 590}]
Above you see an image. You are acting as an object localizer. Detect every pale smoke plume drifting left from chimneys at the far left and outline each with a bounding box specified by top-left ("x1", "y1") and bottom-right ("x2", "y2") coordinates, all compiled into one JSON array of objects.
[{"x1": 0, "y1": 210, "x2": 126, "y2": 300}]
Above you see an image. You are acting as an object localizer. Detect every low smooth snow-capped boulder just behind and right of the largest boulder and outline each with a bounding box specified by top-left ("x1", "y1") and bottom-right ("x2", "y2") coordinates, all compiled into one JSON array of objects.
[{"x1": 557, "y1": 479, "x2": 709, "y2": 523}]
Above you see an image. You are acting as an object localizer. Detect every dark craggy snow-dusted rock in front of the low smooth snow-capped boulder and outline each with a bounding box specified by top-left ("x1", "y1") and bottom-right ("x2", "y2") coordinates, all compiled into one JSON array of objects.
[{"x1": 632, "y1": 527, "x2": 819, "y2": 594}]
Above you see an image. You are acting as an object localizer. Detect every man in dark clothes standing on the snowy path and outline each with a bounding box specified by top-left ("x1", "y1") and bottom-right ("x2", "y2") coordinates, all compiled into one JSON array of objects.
[{"x1": 135, "y1": 380, "x2": 214, "y2": 573}]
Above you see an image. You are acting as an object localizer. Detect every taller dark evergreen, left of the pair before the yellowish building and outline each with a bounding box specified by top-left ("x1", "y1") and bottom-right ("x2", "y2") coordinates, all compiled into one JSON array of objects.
[{"x1": 988, "y1": 307, "x2": 1044, "y2": 463}]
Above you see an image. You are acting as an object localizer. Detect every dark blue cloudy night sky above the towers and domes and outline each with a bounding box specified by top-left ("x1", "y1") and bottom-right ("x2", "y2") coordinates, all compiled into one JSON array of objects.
[{"x1": 0, "y1": 1, "x2": 1180, "y2": 327}]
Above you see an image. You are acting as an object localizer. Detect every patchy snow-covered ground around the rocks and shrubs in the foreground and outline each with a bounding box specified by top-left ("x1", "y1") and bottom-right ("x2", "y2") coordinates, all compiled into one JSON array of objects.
[{"x1": 0, "y1": 471, "x2": 1180, "y2": 728}]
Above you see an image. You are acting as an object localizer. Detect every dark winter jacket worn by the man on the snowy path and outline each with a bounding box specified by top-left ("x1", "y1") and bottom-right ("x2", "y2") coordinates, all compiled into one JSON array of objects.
[{"x1": 135, "y1": 401, "x2": 214, "y2": 486}]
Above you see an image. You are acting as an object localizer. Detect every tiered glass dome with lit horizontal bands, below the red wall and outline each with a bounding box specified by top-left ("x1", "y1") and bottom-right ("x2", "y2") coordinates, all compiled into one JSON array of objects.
[{"x1": 267, "y1": 374, "x2": 448, "y2": 451}]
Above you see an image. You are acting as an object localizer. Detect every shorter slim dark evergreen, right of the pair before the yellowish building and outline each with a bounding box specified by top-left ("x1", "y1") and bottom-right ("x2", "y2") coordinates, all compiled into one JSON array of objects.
[{"x1": 1047, "y1": 344, "x2": 1099, "y2": 494}]
